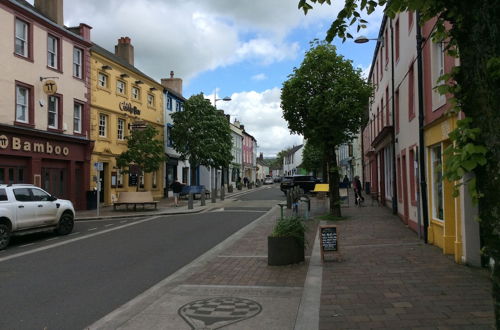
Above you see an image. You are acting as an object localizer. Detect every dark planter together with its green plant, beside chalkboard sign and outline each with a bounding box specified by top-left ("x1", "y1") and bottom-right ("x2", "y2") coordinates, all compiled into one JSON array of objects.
[{"x1": 267, "y1": 217, "x2": 306, "y2": 266}]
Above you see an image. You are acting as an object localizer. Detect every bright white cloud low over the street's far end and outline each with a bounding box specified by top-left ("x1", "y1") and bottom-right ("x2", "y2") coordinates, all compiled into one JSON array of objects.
[{"x1": 216, "y1": 87, "x2": 303, "y2": 157}]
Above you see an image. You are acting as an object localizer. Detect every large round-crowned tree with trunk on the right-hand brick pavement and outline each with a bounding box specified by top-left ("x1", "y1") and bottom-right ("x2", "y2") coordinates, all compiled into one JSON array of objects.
[{"x1": 281, "y1": 40, "x2": 371, "y2": 216}]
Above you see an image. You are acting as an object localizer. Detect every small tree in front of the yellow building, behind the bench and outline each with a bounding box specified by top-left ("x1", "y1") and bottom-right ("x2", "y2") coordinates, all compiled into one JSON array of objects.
[{"x1": 116, "y1": 124, "x2": 166, "y2": 191}]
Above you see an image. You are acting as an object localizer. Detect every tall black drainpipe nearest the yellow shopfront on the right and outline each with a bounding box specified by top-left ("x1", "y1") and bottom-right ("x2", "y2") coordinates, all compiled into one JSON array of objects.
[{"x1": 415, "y1": 11, "x2": 429, "y2": 243}]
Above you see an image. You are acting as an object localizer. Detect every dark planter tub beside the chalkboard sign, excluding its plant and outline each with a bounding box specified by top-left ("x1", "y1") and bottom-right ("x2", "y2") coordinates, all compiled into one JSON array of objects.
[{"x1": 267, "y1": 237, "x2": 304, "y2": 266}]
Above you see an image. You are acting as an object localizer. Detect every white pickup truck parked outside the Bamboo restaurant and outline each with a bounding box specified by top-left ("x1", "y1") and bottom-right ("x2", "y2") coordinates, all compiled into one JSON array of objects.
[{"x1": 0, "y1": 184, "x2": 75, "y2": 250}]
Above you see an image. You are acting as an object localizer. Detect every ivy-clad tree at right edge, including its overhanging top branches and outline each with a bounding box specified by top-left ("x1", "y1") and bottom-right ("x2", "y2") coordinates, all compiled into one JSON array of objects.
[{"x1": 299, "y1": 0, "x2": 500, "y2": 328}]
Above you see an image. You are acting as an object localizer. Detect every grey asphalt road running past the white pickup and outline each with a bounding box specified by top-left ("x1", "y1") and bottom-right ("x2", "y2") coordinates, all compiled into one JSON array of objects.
[{"x1": 0, "y1": 189, "x2": 282, "y2": 329}]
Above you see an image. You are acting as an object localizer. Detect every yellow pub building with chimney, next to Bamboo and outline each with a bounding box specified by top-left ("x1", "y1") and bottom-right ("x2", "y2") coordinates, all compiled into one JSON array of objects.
[{"x1": 90, "y1": 37, "x2": 164, "y2": 205}]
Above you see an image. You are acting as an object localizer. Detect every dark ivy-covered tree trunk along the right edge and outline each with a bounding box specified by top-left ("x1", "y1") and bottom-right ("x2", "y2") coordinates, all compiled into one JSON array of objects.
[{"x1": 453, "y1": 0, "x2": 500, "y2": 329}]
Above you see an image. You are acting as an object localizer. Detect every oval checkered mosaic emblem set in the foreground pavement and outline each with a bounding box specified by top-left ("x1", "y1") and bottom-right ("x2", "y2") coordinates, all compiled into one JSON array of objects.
[{"x1": 178, "y1": 297, "x2": 262, "y2": 329}]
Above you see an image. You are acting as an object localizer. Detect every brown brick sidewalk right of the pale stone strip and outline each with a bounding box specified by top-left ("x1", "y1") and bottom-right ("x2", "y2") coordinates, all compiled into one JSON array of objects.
[{"x1": 320, "y1": 207, "x2": 494, "y2": 329}]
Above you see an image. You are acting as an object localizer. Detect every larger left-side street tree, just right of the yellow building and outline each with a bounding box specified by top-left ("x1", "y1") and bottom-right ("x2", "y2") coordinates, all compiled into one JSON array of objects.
[{"x1": 171, "y1": 94, "x2": 233, "y2": 183}]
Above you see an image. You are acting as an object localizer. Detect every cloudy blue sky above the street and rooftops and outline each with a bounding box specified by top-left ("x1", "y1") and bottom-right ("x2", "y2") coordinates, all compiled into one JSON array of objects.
[{"x1": 40, "y1": 0, "x2": 382, "y2": 157}]
